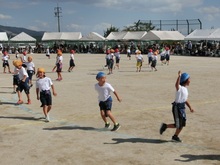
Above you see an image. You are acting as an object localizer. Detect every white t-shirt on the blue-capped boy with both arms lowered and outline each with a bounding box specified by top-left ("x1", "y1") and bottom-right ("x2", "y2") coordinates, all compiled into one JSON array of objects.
[{"x1": 95, "y1": 83, "x2": 115, "y2": 101}]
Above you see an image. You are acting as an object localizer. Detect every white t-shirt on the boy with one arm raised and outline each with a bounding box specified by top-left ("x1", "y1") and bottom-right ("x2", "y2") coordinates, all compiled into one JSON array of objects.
[{"x1": 175, "y1": 85, "x2": 188, "y2": 103}]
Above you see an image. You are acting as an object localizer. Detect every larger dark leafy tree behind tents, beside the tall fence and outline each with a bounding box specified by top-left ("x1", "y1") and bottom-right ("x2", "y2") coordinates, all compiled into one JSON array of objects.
[{"x1": 122, "y1": 20, "x2": 155, "y2": 32}]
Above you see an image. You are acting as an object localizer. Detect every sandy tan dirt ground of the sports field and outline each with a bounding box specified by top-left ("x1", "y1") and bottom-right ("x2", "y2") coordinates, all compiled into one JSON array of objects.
[{"x1": 0, "y1": 54, "x2": 220, "y2": 165}]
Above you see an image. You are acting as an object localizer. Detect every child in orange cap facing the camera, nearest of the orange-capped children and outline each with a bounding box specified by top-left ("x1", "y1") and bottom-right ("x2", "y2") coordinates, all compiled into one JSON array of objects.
[{"x1": 36, "y1": 68, "x2": 57, "y2": 122}]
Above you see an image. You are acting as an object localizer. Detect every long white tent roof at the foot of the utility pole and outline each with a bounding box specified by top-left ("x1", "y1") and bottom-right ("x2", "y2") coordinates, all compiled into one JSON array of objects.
[{"x1": 42, "y1": 32, "x2": 82, "y2": 41}]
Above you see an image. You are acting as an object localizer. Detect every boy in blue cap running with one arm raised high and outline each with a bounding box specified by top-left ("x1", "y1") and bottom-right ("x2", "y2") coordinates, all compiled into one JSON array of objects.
[{"x1": 160, "y1": 71, "x2": 194, "y2": 142}]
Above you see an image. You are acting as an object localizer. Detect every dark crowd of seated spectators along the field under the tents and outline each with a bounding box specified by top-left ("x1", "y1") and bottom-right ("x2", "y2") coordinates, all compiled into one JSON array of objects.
[{"x1": 1, "y1": 41, "x2": 220, "y2": 57}]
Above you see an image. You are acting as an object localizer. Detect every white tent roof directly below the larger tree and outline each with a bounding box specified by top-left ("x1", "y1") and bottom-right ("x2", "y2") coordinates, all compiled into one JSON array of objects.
[{"x1": 106, "y1": 31, "x2": 147, "y2": 41}]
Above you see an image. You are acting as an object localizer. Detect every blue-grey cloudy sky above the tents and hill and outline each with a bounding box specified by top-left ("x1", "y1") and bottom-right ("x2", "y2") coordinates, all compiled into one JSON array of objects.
[{"x1": 0, "y1": 0, "x2": 220, "y2": 35}]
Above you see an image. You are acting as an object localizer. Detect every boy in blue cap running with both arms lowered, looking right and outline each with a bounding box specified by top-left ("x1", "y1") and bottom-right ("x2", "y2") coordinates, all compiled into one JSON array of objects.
[{"x1": 95, "y1": 72, "x2": 121, "y2": 131}]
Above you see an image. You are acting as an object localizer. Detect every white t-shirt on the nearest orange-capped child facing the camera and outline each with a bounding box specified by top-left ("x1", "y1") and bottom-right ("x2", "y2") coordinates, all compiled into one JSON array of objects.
[{"x1": 36, "y1": 77, "x2": 53, "y2": 92}]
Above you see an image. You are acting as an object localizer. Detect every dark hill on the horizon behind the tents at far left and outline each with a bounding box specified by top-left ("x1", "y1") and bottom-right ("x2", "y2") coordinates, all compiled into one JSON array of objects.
[{"x1": 0, "y1": 25, "x2": 44, "y2": 41}]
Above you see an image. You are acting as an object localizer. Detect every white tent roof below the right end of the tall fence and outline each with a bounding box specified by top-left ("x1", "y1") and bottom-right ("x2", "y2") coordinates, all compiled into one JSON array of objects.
[{"x1": 185, "y1": 29, "x2": 216, "y2": 41}]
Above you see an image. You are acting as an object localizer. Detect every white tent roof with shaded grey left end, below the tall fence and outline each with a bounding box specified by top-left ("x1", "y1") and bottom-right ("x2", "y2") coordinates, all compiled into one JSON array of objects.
[{"x1": 141, "y1": 30, "x2": 185, "y2": 41}]
